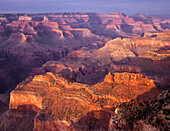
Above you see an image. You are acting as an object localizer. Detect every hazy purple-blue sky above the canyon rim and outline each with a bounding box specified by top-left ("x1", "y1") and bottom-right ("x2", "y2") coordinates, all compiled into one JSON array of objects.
[{"x1": 0, "y1": 0, "x2": 170, "y2": 15}]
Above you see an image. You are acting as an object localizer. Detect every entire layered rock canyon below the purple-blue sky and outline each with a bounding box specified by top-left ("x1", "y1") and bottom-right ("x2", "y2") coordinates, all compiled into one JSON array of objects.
[{"x1": 0, "y1": 12, "x2": 170, "y2": 131}]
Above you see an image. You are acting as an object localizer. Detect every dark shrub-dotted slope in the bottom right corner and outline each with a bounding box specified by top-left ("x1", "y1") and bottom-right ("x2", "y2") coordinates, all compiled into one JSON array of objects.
[{"x1": 109, "y1": 91, "x2": 170, "y2": 131}]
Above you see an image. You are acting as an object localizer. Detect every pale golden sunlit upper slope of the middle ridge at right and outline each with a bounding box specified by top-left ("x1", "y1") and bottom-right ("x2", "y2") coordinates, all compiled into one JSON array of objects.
[{"x1": 65, "y1": 30, "x2": 170, "y2": 65}]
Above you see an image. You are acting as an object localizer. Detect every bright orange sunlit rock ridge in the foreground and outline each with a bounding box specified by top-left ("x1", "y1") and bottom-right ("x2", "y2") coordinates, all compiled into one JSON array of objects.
[{"x1": 9, "y1": 72, "x2": 159, "y2": 130}]
